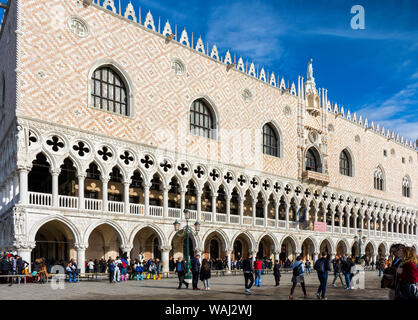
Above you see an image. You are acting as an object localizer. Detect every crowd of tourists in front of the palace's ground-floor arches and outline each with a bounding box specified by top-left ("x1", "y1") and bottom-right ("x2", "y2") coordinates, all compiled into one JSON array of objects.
[{"x1": 0, "y1": 244, "x2": 418, "y2": 300}]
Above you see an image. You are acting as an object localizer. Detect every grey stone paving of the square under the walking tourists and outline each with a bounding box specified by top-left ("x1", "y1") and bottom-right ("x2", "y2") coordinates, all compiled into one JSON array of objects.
[{"x1": 0, "y1": 272, "x2": 388, "y2": 300}]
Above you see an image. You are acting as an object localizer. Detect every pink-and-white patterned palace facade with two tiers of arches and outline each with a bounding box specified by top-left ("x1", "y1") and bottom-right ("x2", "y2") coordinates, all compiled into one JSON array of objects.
[{"x1": 0, "y1": 0, "x2": 418, "y2": 272}]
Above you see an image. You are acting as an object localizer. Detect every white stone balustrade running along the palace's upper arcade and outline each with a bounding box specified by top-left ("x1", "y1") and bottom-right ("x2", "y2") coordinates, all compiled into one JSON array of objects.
[{"x1": 22, "y1": 192, "x2": 416, "y2": 239}]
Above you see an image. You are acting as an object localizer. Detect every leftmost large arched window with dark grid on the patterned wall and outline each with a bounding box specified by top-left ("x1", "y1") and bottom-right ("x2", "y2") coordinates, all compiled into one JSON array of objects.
[{"x1": 91, "y1": 65, "x2": 130, "y2": 116}]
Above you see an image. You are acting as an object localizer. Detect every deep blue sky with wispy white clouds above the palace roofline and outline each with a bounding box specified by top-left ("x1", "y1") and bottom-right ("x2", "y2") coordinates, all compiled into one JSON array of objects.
[{"x1": 0, "y1": 0, "x2": 418, "y2": 140}]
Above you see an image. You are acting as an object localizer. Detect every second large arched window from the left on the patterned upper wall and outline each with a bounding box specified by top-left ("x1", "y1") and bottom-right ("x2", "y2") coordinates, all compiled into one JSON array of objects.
[{"x1": 190, "y1": 99, "x2": 216, "y2": 139}]
